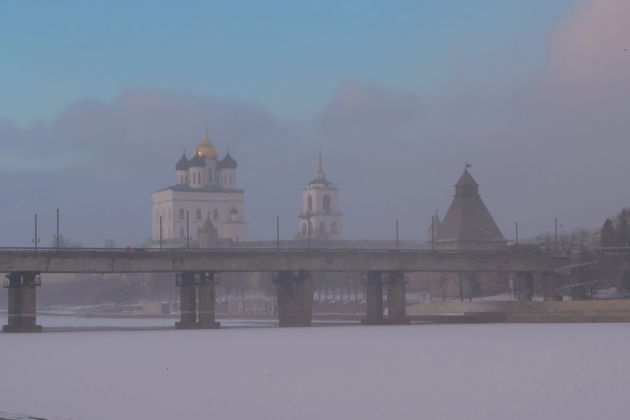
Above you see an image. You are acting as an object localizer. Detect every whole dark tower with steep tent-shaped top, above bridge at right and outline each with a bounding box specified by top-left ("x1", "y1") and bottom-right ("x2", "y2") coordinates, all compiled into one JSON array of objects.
[{"x1": 435, "y1": 168, "x2": 507, "y2": 250}]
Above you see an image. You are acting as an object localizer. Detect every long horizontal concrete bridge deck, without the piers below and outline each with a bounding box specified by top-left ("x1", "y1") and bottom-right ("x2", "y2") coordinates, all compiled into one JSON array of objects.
[{"x1": 0, "y1": 249, "x2": 567, "y2": 273}]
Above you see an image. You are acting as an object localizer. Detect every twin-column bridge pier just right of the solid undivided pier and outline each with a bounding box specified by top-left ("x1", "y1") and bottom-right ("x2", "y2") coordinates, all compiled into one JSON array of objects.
[{"x1": 361, "y1": 271, "x2": 409, "y2": 325}]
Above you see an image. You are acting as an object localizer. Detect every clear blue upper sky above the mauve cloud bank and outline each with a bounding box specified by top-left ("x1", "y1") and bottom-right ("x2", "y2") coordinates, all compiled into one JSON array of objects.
[{"x1": 0, "y1": 0, "x2": 571, "y2": 125}]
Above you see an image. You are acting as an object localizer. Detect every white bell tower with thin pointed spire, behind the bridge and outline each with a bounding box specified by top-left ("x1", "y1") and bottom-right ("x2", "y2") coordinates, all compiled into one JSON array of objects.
[{"x1": 296, "y1": 150, "x2": 342, "y2": 239}]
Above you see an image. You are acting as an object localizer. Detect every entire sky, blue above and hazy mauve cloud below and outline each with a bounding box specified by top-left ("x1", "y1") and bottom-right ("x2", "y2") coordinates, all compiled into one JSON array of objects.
[{"x1": 0, "y1": 0, "x2": 630, "y2": 246}]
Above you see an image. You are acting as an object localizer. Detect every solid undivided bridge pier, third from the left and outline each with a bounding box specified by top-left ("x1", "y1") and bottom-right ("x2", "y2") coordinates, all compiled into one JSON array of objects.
[{"x1": 275, "y1": 271, "x2": 313, "y2": 327}]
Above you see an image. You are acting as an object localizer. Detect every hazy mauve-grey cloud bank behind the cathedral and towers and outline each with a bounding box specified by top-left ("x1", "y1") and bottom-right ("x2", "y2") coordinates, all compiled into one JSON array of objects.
[{"x1": 0, "y1": 0, "x2": 630, "y2": 246}]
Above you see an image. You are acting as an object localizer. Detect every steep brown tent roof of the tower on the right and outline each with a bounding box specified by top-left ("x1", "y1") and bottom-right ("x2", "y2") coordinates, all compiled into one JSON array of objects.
[{"x1": 435, "y1": 170, "x2": 505, "y2": 242}]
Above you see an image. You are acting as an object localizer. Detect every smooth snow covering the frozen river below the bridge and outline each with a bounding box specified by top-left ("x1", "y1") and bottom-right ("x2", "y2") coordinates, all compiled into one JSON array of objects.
[{"x1": 0, "y1": 317, "x2": 630, "y2": 420}]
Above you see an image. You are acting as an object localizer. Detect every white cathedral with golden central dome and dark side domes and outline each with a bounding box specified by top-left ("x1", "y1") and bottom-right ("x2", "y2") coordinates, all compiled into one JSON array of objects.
[{"x1": 152, "y1": 131, "x2": 246, "y2": 246}]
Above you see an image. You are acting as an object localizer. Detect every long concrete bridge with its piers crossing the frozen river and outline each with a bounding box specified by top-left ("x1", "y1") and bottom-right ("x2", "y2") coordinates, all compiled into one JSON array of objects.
[{"x1": 0, "y1": 248, "x2": 630, "y2": 332}]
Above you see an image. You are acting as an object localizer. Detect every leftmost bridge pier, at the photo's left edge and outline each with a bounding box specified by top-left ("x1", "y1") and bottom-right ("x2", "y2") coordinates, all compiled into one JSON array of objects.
[{"x1": 2, "y1": 272, "x2": 42, "y2": 332}]
